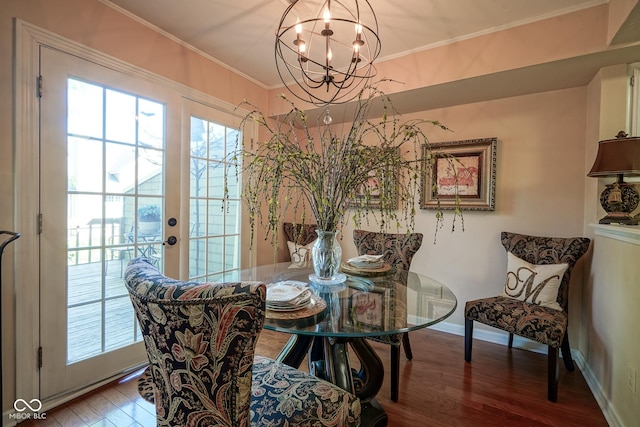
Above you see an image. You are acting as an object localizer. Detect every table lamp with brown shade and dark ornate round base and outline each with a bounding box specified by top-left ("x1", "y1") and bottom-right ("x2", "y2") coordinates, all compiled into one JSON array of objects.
[{"x1": 587, "y1": 131, "x2": 640, "y2": 225}]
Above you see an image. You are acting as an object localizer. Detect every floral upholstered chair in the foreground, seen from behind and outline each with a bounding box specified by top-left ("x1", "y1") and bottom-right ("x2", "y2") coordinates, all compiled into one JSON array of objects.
[{"x1": 125, "y1": 258, "x2": 360, "y2": 427}]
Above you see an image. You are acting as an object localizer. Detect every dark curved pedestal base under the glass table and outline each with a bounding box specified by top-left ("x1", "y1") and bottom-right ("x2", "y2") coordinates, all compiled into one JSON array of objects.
[{"x1": 278, "y1": 335, "x2": 388, "y2": 427}]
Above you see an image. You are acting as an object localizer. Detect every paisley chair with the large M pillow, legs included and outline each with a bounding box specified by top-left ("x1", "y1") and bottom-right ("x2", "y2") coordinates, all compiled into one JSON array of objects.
[{"x1": 464, "y1": 232, "x2": 590, "y2": 402}]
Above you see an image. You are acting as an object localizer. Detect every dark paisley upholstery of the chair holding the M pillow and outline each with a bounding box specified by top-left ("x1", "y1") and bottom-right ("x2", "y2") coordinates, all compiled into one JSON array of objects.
[{"x1": 465, "y1": 232, "x2": 590, "y2": 348}]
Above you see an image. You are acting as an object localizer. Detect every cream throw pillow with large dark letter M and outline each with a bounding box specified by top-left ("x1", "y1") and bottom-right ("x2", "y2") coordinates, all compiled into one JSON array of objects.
[{"x1": 502, "y1": 252, "x2": 569, "y2": 310}]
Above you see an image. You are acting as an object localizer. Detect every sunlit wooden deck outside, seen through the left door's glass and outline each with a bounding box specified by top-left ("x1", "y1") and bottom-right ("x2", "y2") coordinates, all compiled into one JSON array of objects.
[{"x1": 67, "y1": 259, "x2": 141, "y2": 363}]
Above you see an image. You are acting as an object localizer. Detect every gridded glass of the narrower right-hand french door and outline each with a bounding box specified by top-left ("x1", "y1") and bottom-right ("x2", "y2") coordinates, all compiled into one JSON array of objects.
[{"x1": 189, "y1": 117, "x2": 240, "y2": 281}]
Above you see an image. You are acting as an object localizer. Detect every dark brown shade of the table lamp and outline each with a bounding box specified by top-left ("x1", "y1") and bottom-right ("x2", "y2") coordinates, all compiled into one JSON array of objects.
[{"x1": 587, "y1": 132, "x2": 640, "y2": 177}]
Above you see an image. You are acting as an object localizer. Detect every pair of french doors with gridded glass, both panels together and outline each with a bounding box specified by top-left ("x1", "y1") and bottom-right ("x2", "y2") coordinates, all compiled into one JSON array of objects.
[{"x1": 34, "y1": 36, "x2": 250, "y2": 401}]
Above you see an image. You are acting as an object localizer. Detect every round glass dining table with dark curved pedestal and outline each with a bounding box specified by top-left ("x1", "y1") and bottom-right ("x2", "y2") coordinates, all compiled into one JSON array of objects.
[{"x1": 240, "y1": 263, "x2": 457, "y2": 426}]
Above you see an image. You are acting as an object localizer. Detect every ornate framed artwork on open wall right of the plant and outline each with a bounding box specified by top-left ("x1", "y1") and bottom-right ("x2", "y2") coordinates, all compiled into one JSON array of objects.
[{"x1": 420, "y1": 138, "x2": 498, "y2": 211}]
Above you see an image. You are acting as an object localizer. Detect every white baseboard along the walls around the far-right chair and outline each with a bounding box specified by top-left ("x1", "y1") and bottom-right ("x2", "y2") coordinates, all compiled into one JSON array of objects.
[{"x1": 430, "y1": 322, "x2": 624, "y2": 427}]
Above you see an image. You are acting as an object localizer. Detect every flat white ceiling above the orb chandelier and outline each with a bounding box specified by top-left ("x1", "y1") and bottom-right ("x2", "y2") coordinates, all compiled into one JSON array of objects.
[{"x1": 101, "y1": 0, "x2": 607, "y2": 88}]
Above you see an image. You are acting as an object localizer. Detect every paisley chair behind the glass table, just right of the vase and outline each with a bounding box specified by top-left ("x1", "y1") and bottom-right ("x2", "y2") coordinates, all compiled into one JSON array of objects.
[{"x1": 353, "y1": 230, "x2": 423, "y2": 402}]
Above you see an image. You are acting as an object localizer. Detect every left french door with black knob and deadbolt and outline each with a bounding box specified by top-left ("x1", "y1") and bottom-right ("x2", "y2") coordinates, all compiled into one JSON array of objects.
[{"x1": 40, "y1": 47, "x2": 180, "y2": 399}]
